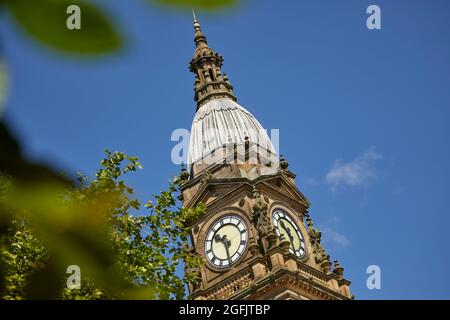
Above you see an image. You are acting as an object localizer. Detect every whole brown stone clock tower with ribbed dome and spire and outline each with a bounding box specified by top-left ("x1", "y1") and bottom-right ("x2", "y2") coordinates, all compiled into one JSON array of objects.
[{"x1": 181, "y1": 16, "x2": 352, "y2": 300}]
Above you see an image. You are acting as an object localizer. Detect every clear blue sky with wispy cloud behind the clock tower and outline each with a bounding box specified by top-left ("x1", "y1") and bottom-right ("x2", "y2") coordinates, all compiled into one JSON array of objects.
[{"x1": 0, "y1": 0, "x2": 450, "y2": 299}]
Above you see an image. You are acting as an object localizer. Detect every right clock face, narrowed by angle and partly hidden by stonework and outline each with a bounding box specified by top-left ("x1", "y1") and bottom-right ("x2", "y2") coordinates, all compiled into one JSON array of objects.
[{"x1": 272, "y1": 210, "x2": 306, "y2": 257}]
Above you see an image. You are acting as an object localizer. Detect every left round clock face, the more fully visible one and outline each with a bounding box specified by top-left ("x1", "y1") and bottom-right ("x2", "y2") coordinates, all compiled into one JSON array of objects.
[{"x1": 205, "y1": 216, "x2": 248, "y2": 268}]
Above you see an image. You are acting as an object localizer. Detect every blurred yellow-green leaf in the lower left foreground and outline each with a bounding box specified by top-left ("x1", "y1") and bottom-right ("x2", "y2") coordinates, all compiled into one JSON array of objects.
[{"x1": 0, "y1": 184, "x2": 152, "y2": 299}]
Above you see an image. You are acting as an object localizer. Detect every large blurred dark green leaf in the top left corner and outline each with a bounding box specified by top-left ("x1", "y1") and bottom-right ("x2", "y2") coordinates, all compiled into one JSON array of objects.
[{"x1": 6, "y1": 0, "x2": 122, "y2": 55}]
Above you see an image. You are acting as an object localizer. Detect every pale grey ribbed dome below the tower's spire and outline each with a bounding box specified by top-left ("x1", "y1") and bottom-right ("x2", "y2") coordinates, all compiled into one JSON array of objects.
[{"x1": 188, "y1": 98, "x2": 275, "y2": 164}]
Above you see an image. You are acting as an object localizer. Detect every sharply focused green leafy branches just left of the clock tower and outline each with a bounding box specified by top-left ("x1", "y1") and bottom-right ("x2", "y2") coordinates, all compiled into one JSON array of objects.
[{"x1": 96, "y1": 152, "x2": 204, "y2": 298}]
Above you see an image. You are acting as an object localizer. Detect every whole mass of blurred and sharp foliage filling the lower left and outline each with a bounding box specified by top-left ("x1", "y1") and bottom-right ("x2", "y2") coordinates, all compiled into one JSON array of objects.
[{"x1": 0, "y1": 151, "x2": 204, "y2": 299}]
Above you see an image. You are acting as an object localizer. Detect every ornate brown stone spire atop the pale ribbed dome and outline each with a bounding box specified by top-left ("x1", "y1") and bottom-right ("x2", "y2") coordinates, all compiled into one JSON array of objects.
[{"x1": 189, "y1": 10, "x2": 237, "y2": 110}]
